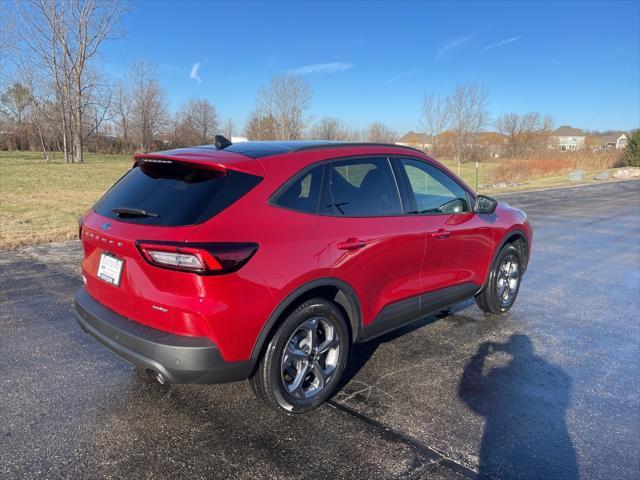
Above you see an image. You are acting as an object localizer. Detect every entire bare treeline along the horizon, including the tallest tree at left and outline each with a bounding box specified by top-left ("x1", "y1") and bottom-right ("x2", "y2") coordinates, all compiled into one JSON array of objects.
[{"x1": 0, "y1": 0, "x2": 552, "y2": 162}]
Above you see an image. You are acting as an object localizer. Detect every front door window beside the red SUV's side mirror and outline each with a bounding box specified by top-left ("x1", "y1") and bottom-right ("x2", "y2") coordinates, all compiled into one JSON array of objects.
[{"x1": 400, "y1": 158, "x2": 471, "y2": 213}]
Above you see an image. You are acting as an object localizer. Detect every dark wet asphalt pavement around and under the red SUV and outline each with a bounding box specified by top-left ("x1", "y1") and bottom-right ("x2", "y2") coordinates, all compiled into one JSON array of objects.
[{"x1": 0, "y1": 181, "x2": 640, "y2": 479}]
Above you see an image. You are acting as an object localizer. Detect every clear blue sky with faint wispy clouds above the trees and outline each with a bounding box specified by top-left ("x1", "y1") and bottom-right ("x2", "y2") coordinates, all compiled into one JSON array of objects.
[{"x1": 103, "y1": 1, "x2": 640, "y2": 133}]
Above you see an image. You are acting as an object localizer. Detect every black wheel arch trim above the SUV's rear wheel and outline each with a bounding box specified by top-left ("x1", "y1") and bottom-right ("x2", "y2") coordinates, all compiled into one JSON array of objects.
[{"x1": 251, "y1": 277, "x2": 362, "y2": 360}]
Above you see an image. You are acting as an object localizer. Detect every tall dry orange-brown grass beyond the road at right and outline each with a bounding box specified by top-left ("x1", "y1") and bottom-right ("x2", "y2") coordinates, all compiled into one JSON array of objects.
[{"x1": 485, "y1": 150, "x2": 620, "y2": 183}]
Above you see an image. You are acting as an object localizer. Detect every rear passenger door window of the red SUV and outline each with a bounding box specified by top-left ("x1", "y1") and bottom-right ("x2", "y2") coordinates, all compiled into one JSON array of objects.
[{"x1": 321, "y1": 157, "x2": 402, "y2": 217}]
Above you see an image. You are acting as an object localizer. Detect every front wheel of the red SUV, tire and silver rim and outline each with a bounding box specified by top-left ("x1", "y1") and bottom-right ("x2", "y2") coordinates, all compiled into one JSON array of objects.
[{"x1": 475, "y1": 244, "x2": 522, "y2": 315}]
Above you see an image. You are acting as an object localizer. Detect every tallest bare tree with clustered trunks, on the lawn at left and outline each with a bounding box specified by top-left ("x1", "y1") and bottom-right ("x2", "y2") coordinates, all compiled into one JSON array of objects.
[{"x1": 15, "y1": 0, "x2": 123, "y2": 162}]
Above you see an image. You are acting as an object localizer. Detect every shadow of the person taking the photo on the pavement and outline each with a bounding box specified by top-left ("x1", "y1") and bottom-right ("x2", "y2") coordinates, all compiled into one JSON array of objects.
[{"x1": 458, "y1": 334, "x2": 579, "y2": 480}]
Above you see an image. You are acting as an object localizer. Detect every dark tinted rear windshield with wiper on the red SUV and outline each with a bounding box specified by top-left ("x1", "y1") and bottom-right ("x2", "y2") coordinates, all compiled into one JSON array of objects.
[{"x1": 93, "y1": 161, "x2": 262, "y2": 226}]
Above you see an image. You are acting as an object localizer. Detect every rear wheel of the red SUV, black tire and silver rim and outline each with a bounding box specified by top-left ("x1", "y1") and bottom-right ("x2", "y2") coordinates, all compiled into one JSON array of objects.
[{"x1": 249, "y1": 298, "x2": 350, "y2": 414}]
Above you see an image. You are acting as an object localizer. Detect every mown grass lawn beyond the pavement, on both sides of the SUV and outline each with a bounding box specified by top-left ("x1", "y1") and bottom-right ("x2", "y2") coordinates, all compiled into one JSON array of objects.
[{"x1": 0, "y1": 151, "x2": 620, "y2": 249}]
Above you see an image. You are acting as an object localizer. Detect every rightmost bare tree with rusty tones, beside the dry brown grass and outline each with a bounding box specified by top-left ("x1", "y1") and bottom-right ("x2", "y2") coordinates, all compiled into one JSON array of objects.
[{"x1": 495, "y1": 112, "x2": 553, "y2": 158}]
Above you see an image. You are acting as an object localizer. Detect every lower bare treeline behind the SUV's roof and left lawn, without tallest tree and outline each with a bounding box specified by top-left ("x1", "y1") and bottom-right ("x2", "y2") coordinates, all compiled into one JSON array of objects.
[{"x1": 0, "y1": 64, "x2": 398, "y2": 158}]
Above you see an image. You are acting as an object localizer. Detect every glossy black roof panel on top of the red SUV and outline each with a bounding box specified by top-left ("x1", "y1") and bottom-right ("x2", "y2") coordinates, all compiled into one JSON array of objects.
[{"x1": 195, "y1": 140, "x2": 422, "y2": 158}]
